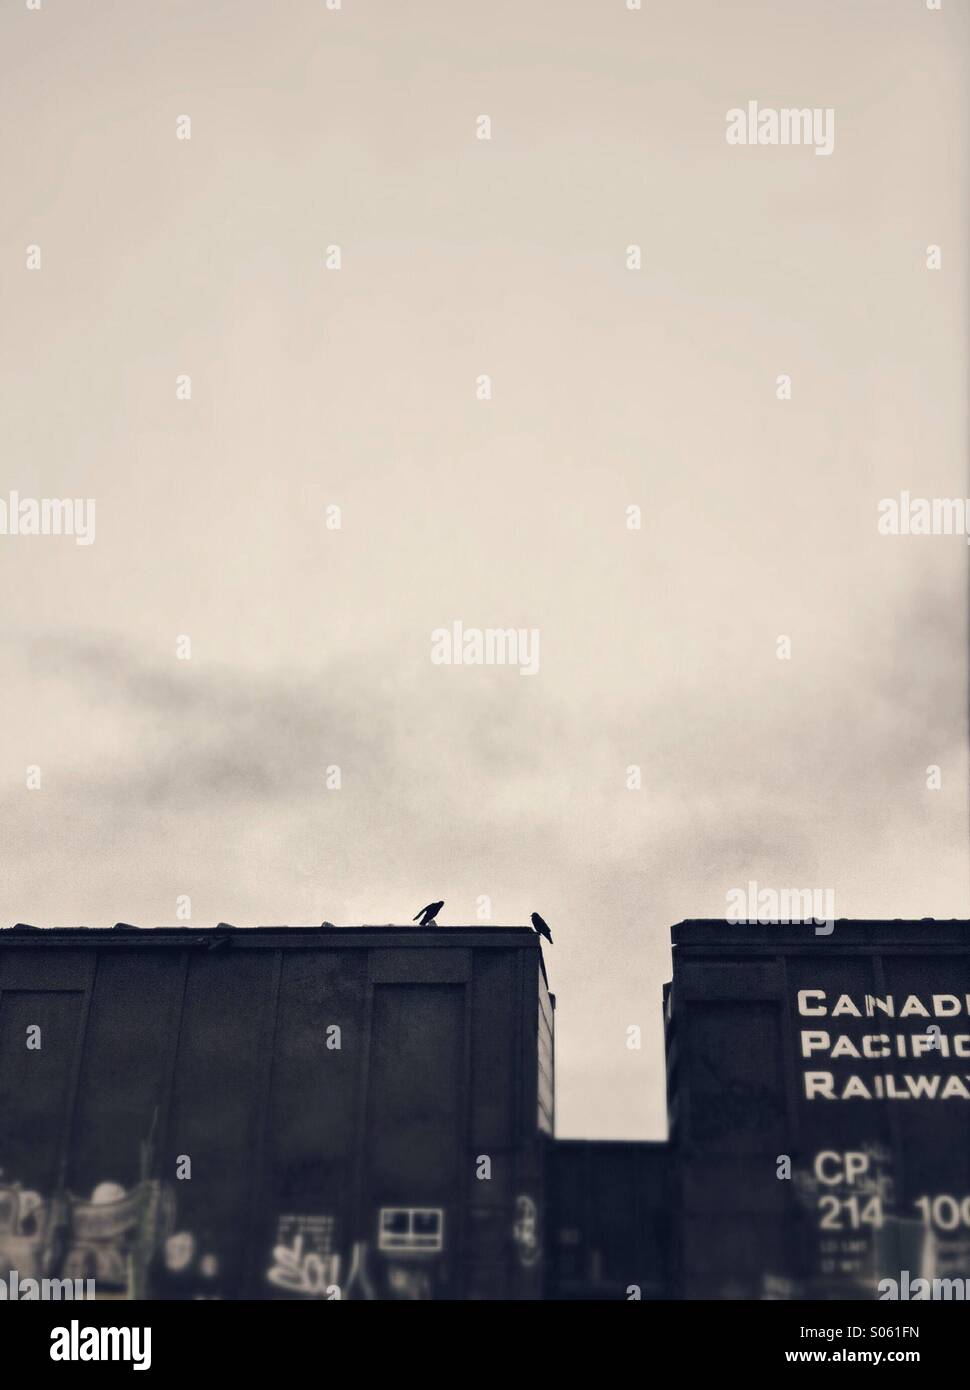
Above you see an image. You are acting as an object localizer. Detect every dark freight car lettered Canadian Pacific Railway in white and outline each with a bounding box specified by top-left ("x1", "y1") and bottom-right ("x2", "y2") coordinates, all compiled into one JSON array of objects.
[{"x1": 664, "y1": 922, "x2": 970, "y2": 1298}]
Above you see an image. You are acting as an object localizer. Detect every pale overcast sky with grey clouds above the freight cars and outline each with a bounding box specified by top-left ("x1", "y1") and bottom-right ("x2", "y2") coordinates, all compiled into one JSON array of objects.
[{"x1": 0, "y1": 0, "x2": 969, "y2": 1137}]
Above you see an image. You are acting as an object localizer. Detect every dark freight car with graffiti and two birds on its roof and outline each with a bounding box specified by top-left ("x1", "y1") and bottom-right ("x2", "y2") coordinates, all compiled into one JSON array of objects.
[{"x1": 0, "y1": 927, "x2": 553, "y2": 1300}]
